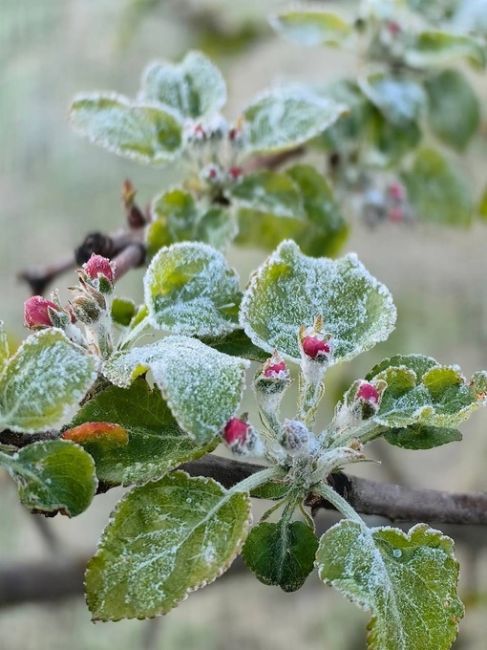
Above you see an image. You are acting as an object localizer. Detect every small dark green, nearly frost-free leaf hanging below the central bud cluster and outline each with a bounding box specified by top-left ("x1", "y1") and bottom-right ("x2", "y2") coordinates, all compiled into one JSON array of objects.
[{"x1": 242, "y1": 520, "x2": 318, "y2": 591}]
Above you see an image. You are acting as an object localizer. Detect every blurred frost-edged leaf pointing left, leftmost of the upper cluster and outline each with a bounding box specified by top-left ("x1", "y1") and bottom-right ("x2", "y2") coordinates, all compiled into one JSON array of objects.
[{"x1": 70, "y1": 93, "x2": 182, "y2": 164}]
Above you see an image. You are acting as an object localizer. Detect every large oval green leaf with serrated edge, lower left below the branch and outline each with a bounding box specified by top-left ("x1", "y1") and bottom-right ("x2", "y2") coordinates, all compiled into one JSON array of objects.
[{"x1": 85, "y1": 472, "x2": 251, "y2": 621}]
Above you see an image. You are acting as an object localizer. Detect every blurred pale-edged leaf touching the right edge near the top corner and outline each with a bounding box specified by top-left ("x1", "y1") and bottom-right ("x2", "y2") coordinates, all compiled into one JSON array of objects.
[{"x1": 404, "y1": 30, "x2": 486, "y2": 68}]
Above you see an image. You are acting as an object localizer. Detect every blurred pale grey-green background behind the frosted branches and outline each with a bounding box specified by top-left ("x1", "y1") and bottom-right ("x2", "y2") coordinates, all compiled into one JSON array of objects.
[{"x1": 0, "y1": 0, "x2": 487, "y2": 650}]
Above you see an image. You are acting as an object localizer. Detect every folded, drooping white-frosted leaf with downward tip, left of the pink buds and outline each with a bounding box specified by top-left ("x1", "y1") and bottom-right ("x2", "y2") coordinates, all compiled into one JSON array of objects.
[{"x1": 104, "y1": 336, "x2": 249, "y2": 444}]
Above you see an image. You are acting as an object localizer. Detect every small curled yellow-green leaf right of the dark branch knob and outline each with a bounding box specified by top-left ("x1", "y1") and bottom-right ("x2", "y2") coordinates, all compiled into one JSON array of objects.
[{"x1": 146, "y1": 188, "x2": 237, "y2": 255}]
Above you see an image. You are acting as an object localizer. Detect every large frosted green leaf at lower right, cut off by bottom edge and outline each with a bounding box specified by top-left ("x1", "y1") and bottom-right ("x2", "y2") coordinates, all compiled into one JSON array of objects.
[{"x1": 316, "y1": 520, "x2": 464, "y2": 650}]
